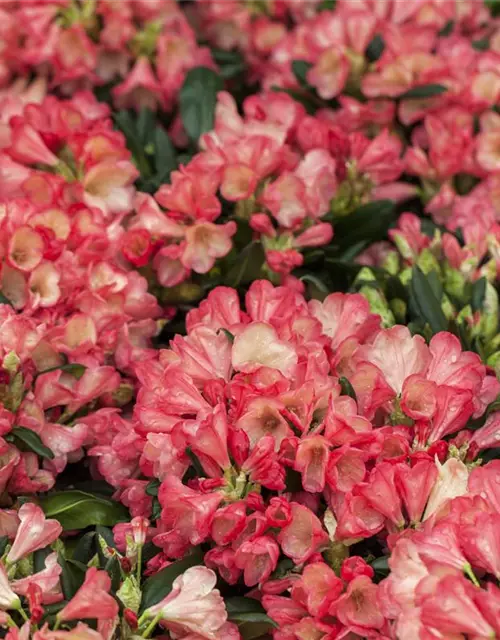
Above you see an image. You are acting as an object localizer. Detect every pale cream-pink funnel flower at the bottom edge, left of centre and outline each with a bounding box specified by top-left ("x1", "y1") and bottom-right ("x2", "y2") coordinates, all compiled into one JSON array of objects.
[{"x1": 145, "y1": 567, "x2": 227, "y2": 640}]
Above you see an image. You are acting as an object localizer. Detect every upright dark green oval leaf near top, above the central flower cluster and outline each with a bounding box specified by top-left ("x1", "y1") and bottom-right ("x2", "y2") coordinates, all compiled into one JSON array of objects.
[{"x1": 179, "y1": 67, "x2": 224, "y2": 143}]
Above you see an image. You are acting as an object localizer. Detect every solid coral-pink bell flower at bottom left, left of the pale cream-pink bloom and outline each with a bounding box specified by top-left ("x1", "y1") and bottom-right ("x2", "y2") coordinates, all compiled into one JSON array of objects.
[{"x1": 57, "y1": 567, "x2": 118, "y2": 620}]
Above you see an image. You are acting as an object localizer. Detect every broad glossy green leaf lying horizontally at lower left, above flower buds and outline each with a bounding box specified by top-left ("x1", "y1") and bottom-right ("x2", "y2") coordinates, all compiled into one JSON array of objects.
[{"x1": 40, "y1": 491, "x2": 129, "y2": 531}]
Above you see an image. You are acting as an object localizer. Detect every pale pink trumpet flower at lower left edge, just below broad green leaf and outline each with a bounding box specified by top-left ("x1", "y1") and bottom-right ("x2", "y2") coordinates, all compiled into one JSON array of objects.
[{"x1": 7, "y1": 502, "x2": 62, "y2": 564}]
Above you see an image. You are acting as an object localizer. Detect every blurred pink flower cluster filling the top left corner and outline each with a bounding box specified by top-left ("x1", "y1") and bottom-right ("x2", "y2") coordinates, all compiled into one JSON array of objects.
[{"x1": 0, "y1": 0, "x2": 215, "y2": 110}]
